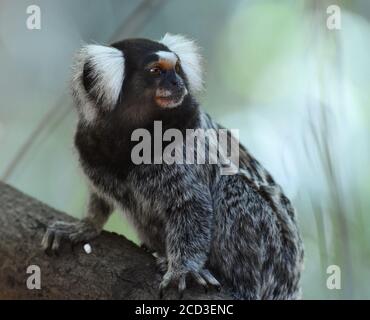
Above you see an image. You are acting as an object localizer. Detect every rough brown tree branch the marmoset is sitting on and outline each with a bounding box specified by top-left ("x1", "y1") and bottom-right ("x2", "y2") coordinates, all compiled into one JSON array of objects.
[{"x1": 0, "y1": 182, "x2": 228, "y2": 299}]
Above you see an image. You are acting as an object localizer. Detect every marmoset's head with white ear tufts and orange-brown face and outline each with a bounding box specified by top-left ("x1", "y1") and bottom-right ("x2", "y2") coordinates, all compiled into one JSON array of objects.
[{"x1": 72, "y1": 35, "x2": 202, "y2": 122}]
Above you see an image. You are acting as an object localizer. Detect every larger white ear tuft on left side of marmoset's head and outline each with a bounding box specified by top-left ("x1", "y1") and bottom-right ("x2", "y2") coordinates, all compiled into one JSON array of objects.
[{"x1": 72, "y1": 45, "x2": 125, "y2": 121}]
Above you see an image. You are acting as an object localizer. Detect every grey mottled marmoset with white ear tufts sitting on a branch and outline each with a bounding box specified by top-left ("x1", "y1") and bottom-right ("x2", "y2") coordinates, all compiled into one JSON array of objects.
[{"x1": 42, "y1": 34, "x2": 303, "y2": 299}]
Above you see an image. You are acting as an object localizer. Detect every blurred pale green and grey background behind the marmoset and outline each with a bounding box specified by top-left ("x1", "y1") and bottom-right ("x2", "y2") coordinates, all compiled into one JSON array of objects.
[{"x1": 0, "y1": 0, "x2": 370, "y2": 299}]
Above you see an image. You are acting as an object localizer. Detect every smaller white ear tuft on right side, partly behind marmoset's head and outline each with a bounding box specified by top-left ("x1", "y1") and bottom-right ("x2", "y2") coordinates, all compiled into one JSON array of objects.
[{"x1": 159, "y1": 33, "x2": 203, "y2": 93}]
